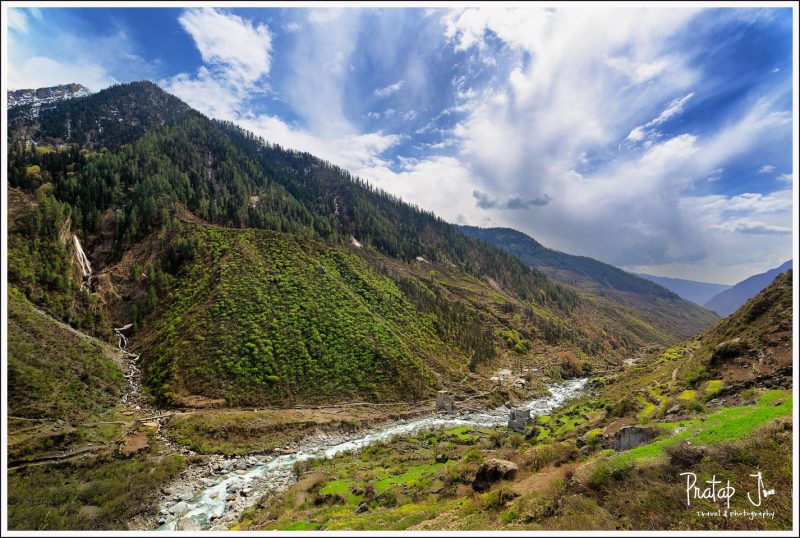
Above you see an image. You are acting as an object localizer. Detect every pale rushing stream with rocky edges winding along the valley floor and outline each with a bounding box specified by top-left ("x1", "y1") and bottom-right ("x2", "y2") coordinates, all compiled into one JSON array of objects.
[{"x1": 157, "y1": 379, "x2": 586, "y2": 531}]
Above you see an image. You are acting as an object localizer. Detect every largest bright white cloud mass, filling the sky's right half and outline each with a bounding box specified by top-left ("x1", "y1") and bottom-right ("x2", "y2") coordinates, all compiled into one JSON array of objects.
[{"x1": 428, "y1": 7, "x2": 791, "y2": 278}]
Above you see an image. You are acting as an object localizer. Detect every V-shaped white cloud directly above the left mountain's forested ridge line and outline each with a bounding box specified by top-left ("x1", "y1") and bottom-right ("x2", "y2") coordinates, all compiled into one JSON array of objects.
[{"x1": 162, "y1": 9, "x2": 402, "y2": 178}]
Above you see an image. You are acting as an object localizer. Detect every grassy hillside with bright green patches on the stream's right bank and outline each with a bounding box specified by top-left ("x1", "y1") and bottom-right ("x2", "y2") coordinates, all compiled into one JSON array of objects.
[{"x1": 238, "y1": 271, "x2": 794, "y2": 531}]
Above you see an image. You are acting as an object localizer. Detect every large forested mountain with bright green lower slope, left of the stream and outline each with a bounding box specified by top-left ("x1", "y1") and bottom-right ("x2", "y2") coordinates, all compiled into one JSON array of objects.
[{"x1": 8, "y1": 82, "x2": 714, "y2": 406}]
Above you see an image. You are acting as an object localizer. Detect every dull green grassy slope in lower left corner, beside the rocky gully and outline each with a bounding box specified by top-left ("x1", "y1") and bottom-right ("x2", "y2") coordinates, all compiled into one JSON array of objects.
[{"x1": 3, "y1": 288, "x2": 186, "y2": 531}]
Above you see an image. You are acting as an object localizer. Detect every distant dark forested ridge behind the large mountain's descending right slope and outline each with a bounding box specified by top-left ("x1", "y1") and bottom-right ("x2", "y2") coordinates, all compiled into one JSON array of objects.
[{"x1": 459, "y1": 226, "x2": 715, "y2": 338}]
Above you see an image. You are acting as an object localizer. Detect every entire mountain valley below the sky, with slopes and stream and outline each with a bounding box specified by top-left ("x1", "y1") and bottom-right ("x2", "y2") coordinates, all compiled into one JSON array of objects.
[{"x1": 7, "y1": 81, "x2": 793, "y2": 531}]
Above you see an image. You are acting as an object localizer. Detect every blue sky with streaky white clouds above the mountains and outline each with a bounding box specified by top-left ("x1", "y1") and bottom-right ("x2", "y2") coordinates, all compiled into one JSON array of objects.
[{"x1": 4, "y1": 4, "x2": 797, "y2": 284}]
